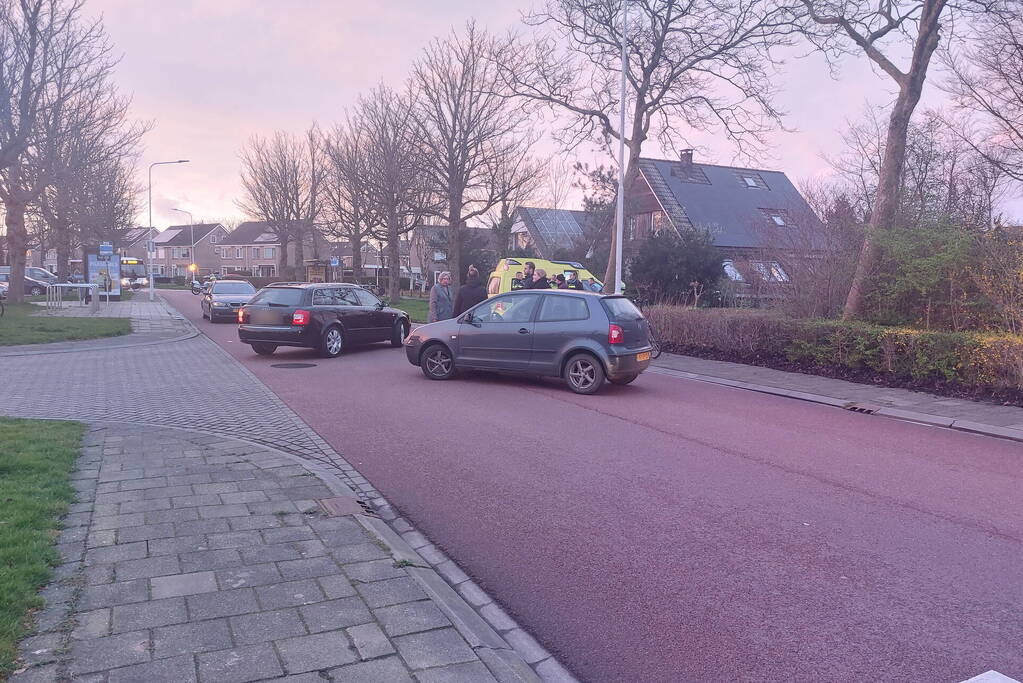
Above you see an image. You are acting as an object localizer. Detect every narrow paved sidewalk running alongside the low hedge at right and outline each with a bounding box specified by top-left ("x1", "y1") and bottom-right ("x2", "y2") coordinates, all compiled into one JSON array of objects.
[{"x1": 653, "y1": 354, "x2": 1023, "y2": 439}]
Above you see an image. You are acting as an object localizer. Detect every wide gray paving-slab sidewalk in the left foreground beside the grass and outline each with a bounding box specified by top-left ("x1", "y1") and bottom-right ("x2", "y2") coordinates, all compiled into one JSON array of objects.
[{"x1": 11, "y1": 425, "x2": 511, "y2": 683}]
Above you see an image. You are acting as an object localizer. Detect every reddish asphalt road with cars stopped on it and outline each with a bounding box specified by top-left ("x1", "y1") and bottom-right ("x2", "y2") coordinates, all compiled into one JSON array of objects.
[{"x1": 164, "y1": 291, "x2": 1023, "y2": 682}]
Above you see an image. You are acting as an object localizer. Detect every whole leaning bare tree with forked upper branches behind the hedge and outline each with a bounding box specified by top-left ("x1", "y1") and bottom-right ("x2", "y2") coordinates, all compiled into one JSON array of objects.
[{"x1": 801, "y1": 0, "x2": 999, "y2": 319}]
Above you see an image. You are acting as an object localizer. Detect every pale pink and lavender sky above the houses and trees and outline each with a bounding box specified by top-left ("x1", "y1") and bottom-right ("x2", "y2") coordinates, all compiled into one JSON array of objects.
[{"x1": 86, "y1": 0, "x2": 1023, "y2": 229}]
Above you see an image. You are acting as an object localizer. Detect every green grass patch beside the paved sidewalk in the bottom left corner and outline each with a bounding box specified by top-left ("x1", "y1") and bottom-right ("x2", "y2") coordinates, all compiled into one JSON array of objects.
[{"x1": 0, "y1": 417, "x2": 85, "y2": 680}]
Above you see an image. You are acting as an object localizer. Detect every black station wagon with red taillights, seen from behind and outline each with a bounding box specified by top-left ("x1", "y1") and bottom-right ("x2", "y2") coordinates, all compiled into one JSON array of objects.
[{"x1": 238, "y1": 282, "x2": 411, "y2": 358}]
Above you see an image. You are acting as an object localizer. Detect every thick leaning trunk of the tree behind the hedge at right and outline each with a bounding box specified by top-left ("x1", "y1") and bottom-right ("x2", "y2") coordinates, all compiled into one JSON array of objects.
[{"x1": 842, "y1": 0, "x2": 946, "y2": 320}]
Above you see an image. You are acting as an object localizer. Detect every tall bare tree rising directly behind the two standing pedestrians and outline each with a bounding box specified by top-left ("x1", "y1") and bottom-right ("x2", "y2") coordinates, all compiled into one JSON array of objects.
[{"x1": 412, "y1": 22, "x2": 533, "y2": 281}]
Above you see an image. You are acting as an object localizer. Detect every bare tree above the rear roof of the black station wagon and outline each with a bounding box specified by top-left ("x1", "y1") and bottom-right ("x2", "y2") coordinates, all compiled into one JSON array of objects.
[{"x1": 238, "y1": 125, "x2": 323, "y2": 277}]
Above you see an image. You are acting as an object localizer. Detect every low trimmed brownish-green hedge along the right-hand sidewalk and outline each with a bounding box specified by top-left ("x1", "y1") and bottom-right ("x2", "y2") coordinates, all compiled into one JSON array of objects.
[{"x1": 647, "y1": 306, "x2": 1023, "y2": 393}]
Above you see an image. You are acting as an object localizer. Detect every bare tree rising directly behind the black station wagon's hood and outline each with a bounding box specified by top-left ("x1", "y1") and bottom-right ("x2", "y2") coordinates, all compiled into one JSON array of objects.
[{"x1": 353, "y1": 85, "x2": 433, "y2": 302}]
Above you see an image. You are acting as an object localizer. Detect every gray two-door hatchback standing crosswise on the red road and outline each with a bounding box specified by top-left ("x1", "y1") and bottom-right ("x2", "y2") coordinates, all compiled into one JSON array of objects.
[{"x1": 405, "y1": 289, "x2": 652, "y2": 394}]
